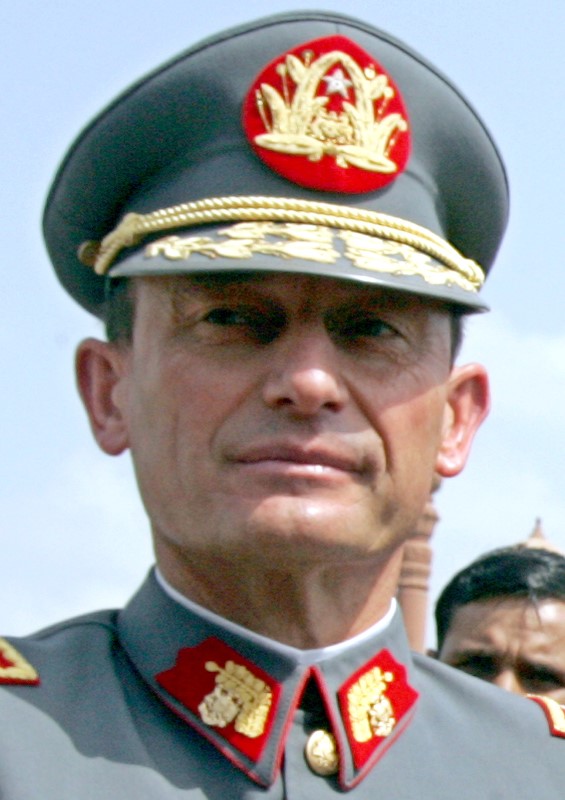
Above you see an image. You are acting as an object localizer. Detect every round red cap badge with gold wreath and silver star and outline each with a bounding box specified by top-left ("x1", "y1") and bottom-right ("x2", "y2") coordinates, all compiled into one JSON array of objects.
[{"x1": 243, "y1": 36, "x2": 410, "y2": 194}]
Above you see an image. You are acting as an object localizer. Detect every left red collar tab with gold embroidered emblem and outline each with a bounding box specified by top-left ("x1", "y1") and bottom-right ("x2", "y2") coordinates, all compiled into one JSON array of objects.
[{"x1": 155, "y1": 638, "x2": 280, "y2": 763}]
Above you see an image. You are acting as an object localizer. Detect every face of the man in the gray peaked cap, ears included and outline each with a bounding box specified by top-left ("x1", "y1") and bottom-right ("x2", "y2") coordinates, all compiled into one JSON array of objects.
[{"x1": 78, "y1": 274, "x2": 487, "y2": 565}]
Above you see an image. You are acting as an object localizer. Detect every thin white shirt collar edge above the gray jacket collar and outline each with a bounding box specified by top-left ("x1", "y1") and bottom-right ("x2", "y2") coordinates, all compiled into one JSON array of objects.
[{"x1": 155, "y1": 567, "x2": 396, "y2": 665}]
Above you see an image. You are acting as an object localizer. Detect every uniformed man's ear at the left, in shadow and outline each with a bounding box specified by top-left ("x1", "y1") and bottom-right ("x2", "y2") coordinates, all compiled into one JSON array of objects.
[{"x1": 75, "y1": 339, "x2": 129, "y2": 456}]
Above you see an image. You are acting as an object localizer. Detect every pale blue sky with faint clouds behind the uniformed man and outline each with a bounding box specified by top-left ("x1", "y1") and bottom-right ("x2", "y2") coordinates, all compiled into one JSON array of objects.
[{"x1": 4, "y1": 0, "x2": 565, "y2": 634}]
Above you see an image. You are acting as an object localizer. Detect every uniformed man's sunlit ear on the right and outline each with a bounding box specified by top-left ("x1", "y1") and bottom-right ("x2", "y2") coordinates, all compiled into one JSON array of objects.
[{"x1": 436, "y1": 364, "x2": 490, "y2": 478}]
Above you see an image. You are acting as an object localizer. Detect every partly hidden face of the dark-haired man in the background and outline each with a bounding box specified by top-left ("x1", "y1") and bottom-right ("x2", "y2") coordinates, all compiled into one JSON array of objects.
[{"x1": 440, "y1": 598, "x2": 565, "y2": 703}]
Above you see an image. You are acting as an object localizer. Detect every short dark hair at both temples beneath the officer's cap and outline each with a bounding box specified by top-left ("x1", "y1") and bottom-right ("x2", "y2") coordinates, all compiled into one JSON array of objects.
[{"x1": 104, "y1": 278, "x2": 467, "y2": 362}]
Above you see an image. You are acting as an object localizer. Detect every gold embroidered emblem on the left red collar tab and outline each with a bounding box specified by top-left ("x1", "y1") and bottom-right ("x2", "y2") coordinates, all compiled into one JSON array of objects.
[{"x1": 198, "y1": 661, "x2": 272, "y2": 739}]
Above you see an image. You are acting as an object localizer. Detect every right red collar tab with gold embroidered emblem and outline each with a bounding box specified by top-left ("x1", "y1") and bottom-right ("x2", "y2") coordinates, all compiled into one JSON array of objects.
[{"x1": 338, "y1": 650, "x2": 419, "y2": 770}]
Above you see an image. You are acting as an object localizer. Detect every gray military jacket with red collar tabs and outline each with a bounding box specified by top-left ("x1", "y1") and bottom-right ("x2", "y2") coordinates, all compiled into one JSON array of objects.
[{"x1": 0, "y1": 574, "x2": 565, "y2": 800}]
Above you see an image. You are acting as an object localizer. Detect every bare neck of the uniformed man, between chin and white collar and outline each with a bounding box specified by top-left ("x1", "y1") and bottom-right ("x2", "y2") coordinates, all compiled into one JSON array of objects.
[{"x1": 152, "y1": 548, "x2": 402, "y2": 650}]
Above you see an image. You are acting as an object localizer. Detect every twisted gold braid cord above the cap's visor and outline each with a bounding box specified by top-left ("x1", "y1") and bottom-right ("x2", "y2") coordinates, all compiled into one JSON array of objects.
[{"x1": 79, "y1": 196, "x2": 484, "y2": 290}]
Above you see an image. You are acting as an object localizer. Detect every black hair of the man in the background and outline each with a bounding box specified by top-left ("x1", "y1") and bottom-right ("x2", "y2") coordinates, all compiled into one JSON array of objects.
[{"x1": 435, "y1": 545, "x2": 565, "y2": 653}]
